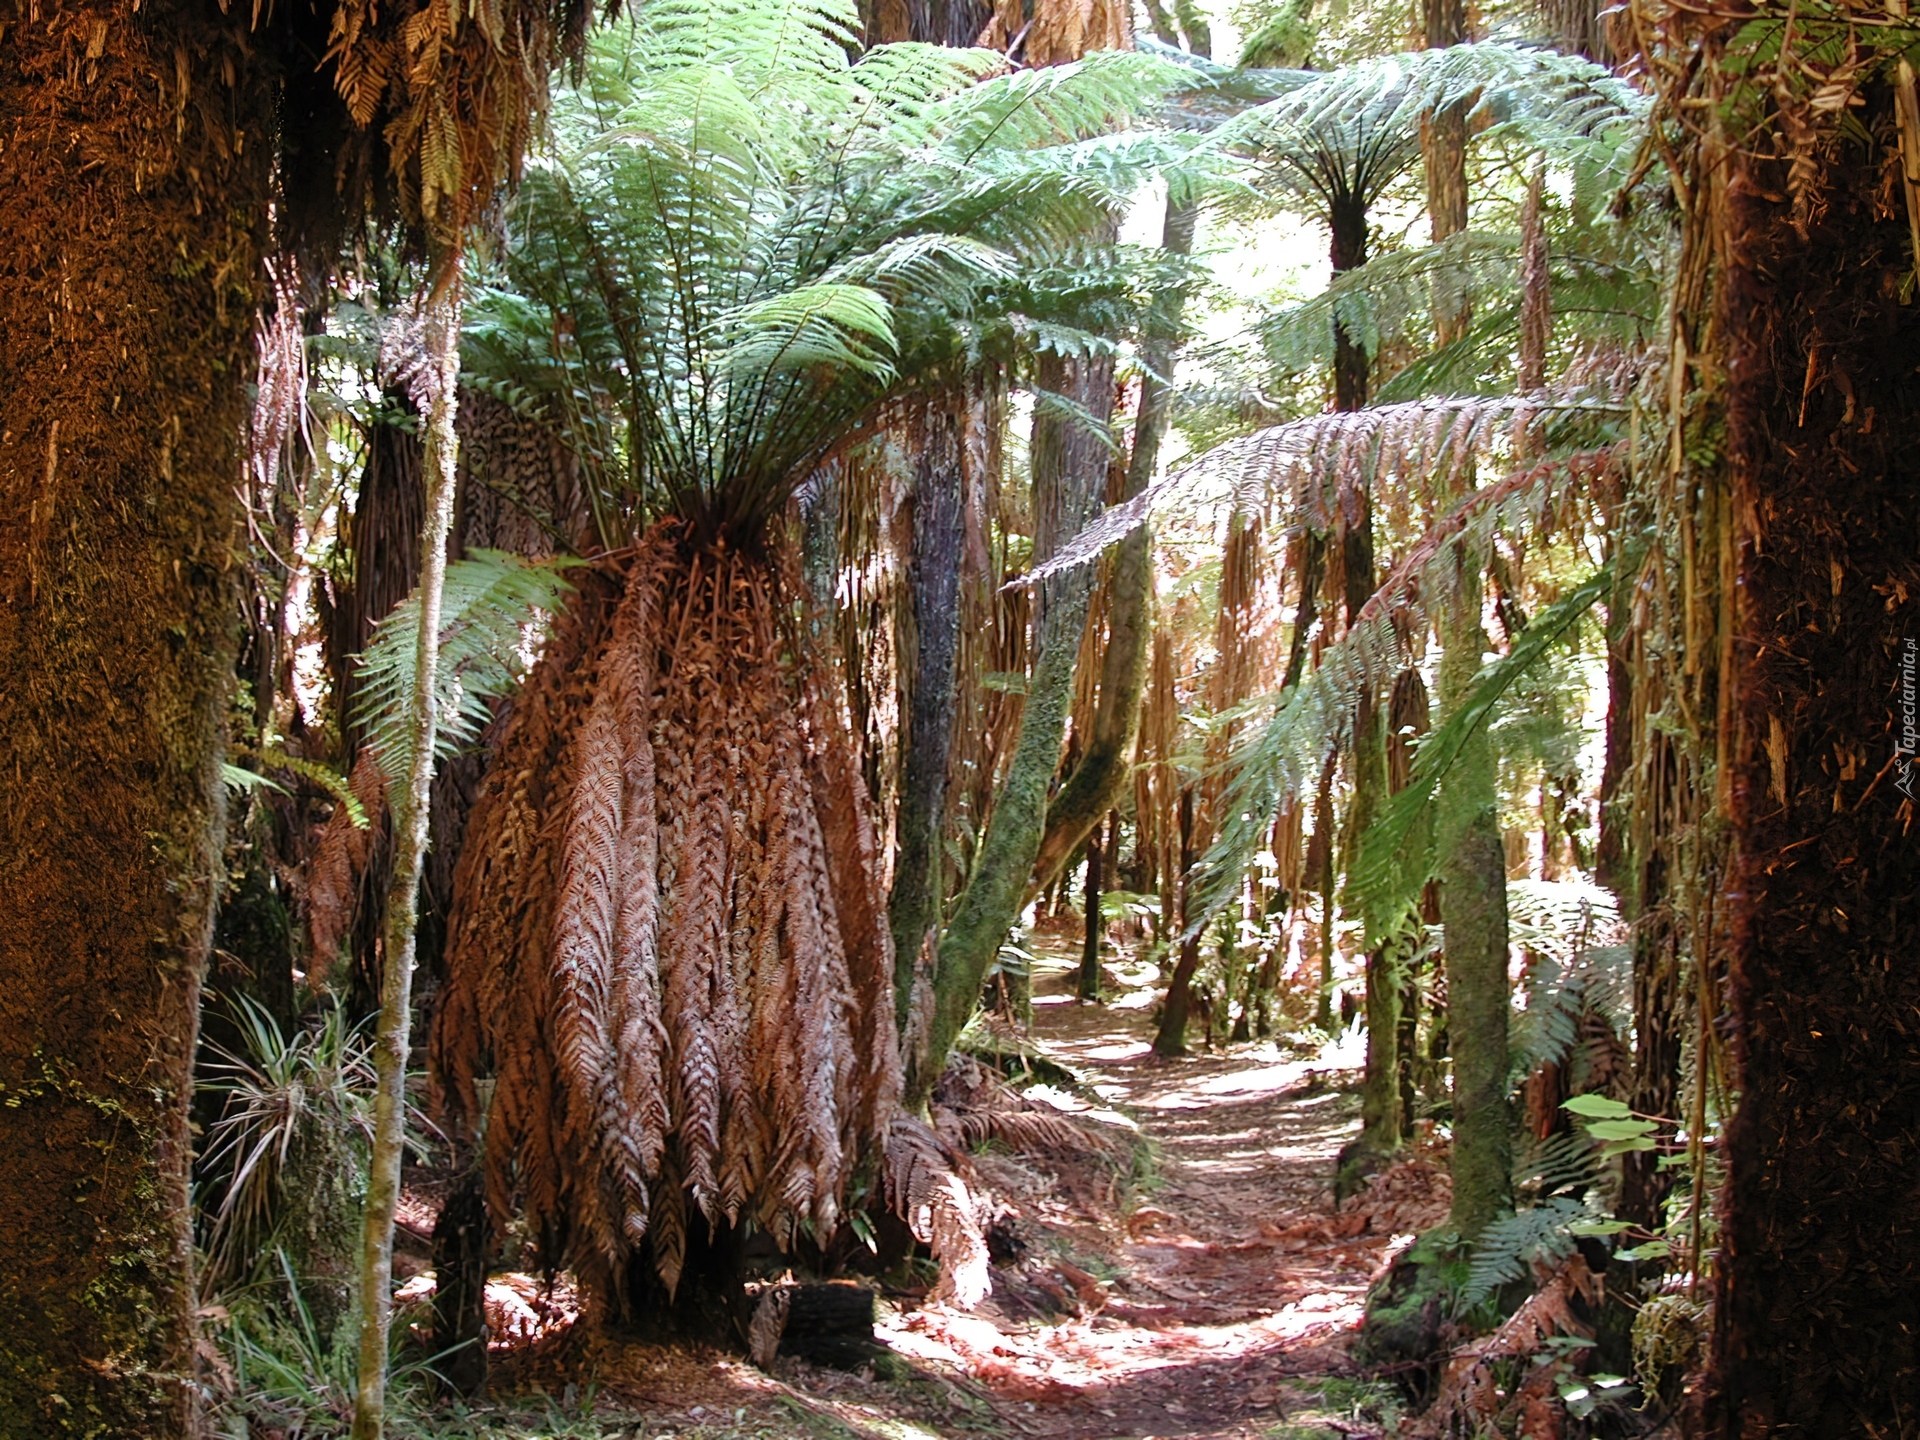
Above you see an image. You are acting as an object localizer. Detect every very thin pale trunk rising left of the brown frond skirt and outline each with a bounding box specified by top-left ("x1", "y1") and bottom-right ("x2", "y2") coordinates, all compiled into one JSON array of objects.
[{"x1": 353, "y1": 282, "x2": 461, "y2": 1440}]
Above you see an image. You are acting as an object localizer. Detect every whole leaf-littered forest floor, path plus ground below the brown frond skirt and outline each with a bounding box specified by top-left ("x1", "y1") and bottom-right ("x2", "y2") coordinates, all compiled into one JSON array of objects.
[{"x1": 270, "y1": 933, "x2": 1448, "y2": 1440}]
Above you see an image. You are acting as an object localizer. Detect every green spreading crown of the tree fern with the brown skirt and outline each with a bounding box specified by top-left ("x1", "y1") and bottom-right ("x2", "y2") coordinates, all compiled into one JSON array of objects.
[{"x1": 470, "y1": 0, "x2": 1190, "y2": 540}]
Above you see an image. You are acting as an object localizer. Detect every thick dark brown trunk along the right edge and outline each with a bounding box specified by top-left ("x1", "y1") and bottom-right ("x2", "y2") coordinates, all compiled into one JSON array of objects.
[{"x1": 1709, "y1": 141, "x2": 1920, "y2": 1436}]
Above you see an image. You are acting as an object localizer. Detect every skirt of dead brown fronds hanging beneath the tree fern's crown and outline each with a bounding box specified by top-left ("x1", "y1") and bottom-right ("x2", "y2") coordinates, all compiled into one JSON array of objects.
[{"x1": 434, "y1": 524, "x2": 921, "y2": 1294}]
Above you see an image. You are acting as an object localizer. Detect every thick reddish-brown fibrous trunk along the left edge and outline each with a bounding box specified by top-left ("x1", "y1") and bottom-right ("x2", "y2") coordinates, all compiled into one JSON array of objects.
[{"x1": 0, "y1": 0, "x2": 273, "y2": 1440}]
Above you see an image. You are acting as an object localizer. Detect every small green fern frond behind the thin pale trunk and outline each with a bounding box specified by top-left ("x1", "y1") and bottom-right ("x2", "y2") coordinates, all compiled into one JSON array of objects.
[{"x1": 357, "y1": 549, "x2": 578, "y2": 783}]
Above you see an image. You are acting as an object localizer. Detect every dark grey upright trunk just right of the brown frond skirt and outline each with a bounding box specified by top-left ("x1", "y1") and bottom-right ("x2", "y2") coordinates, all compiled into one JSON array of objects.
[{"x1": 887, "y1": 390, "x2": 966, "y2": 1031}]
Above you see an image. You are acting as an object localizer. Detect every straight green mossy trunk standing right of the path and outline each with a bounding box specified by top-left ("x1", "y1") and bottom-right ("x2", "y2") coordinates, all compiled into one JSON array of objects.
[{"x1": 1434, "y1": 578, "x2": 1513, "y2": 1242}]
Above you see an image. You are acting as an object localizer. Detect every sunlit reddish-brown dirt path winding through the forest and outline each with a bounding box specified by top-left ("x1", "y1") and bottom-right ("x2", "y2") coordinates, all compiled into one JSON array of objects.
[{"x1": 887, "y1": 941, "x2": 1394, "y2": 1440}]
